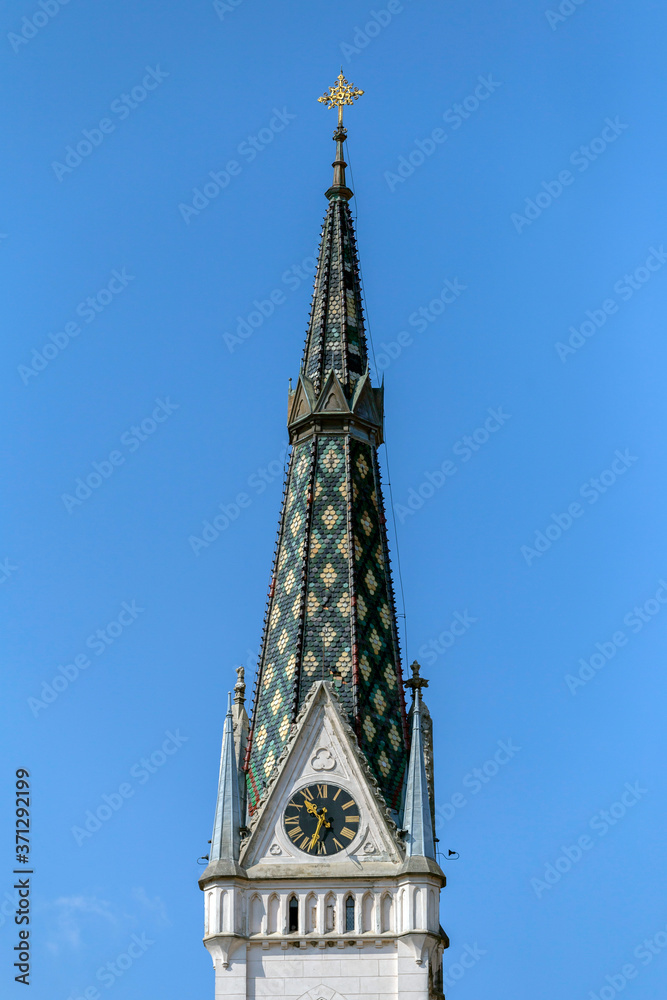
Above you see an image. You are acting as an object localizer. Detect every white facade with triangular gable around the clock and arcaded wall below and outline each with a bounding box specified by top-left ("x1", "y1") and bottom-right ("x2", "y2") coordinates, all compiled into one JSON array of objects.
[{"x1": 200, "y1": 684, "x2": 448, "y2": 1000}]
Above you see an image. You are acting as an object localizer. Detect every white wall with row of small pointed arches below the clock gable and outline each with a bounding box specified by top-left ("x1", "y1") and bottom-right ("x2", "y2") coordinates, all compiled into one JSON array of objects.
[{"x1": 204, "y1": 875, "x2": 444, "y2": 1000}]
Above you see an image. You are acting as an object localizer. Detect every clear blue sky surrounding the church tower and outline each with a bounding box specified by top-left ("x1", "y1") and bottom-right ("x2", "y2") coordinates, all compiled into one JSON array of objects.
[{"x1": 0, "y1": 0, "x2": 667, "y2": 1000}]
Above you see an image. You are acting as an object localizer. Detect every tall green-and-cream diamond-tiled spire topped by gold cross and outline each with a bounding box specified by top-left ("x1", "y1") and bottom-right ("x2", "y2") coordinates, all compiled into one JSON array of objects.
[{"x1": 245, "y1": 74, "x2": 408, "y2": 813}]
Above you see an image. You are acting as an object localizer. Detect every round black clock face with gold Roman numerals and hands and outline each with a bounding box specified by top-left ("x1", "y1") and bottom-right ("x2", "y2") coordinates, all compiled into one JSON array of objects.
[{"x1": 283, "y1": 784, "x2": 360, "y2": 856}]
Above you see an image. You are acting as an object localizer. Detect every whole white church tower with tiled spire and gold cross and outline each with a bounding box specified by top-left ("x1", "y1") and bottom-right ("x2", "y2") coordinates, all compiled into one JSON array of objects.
[{"x1": 199, "y1": 73, "x2": 448, "y2": 1000}]
